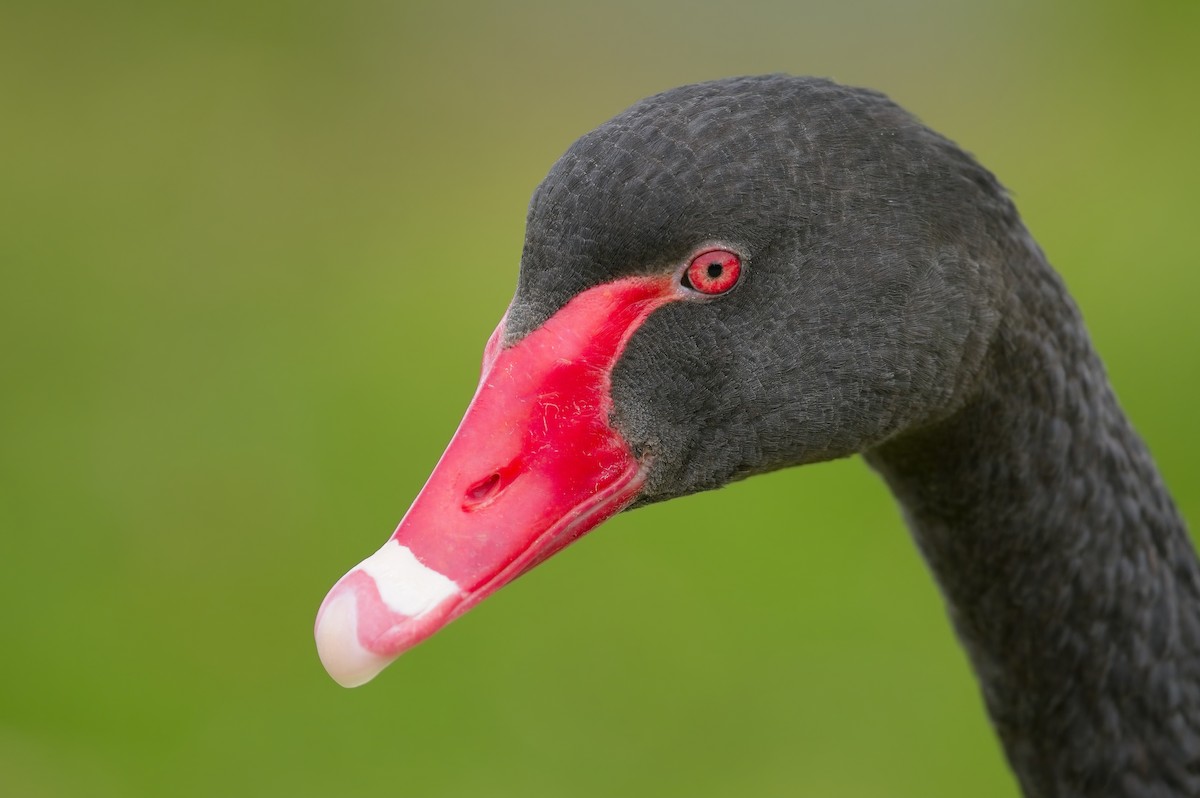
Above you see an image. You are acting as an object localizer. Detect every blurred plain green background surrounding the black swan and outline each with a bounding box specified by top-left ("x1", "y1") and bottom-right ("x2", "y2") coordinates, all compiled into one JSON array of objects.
[{"x1": 0, "y1": 0, "x2": 1200, "y2": 798}]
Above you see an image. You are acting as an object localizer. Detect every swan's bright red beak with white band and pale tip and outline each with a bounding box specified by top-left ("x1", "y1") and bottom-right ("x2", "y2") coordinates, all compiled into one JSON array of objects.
[{"x1": 316, "y1": 277, "x2": 680, "y2": 688}]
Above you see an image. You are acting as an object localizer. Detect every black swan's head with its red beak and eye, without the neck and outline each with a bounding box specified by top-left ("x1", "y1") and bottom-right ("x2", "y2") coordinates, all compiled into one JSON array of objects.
[{"x1": 316, "y1": 76, "x2": 1021, "y2": 685}]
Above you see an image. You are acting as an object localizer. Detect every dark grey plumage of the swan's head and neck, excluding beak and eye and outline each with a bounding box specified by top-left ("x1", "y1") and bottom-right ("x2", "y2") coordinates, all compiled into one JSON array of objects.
[{"x1": 505, "y1": 76, "x2": 1200, "y2": 798}]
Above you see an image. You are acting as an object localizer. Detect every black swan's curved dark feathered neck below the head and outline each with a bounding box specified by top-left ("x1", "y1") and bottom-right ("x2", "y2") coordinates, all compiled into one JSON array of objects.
[{"x1": 868, "y1": 253, "x2": 1200, "y2": 798}]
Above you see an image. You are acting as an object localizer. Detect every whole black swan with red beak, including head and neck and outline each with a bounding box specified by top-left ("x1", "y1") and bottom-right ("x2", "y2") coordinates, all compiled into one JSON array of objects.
[{"x1": 316, "y1": 76, "x2": 1200, "y2": 798}]
